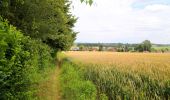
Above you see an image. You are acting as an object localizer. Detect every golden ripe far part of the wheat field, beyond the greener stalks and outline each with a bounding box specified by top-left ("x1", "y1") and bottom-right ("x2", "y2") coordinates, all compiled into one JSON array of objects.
[{"x1": 66, "y1": 52, "x2": 170, "y2": 79}]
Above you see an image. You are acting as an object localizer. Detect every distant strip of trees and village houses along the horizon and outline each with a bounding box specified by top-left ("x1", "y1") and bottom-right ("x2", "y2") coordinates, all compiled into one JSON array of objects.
[{"x1": 75, "y1": 40, "x2": 170, "y2": 52}]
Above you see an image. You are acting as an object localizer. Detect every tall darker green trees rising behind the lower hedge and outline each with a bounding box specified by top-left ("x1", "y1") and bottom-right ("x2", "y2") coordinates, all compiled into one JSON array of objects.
[{"x1": 0, "y1": 0, "x2": 76, "y2": 50}]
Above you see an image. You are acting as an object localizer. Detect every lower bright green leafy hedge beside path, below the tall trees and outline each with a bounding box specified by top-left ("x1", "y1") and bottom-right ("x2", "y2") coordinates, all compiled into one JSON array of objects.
[{"x1": 0, "y1": 18, "x2": 53, "y2": 100}]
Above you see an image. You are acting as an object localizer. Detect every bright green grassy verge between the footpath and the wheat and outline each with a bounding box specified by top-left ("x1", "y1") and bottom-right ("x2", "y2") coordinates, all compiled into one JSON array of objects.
[{"x1": 61, "y1": 62, "x2": 97, "y2": 100}]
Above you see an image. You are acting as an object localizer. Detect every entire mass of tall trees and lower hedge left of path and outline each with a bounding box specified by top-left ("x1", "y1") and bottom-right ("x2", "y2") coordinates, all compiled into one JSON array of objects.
[{"x1": 0, "y1": 0, "x2": 76, "y2": 100}]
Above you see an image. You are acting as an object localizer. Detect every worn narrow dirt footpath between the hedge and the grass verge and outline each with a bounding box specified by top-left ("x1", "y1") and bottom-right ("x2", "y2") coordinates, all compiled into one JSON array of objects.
[{"x1": 38, "y1": 67, "x2": 61, "y2": 100}]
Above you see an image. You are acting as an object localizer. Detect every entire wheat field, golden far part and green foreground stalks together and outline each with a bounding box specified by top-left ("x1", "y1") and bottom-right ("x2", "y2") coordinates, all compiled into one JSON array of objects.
[{"x1": 66, "y1": 52, "x2": 170, "y2": 100}]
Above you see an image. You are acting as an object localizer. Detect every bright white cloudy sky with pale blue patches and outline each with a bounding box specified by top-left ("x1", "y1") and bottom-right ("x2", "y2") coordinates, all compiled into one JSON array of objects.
[{"x1": 71, "y1": 0, "x2": 170, "y2": 44}]
